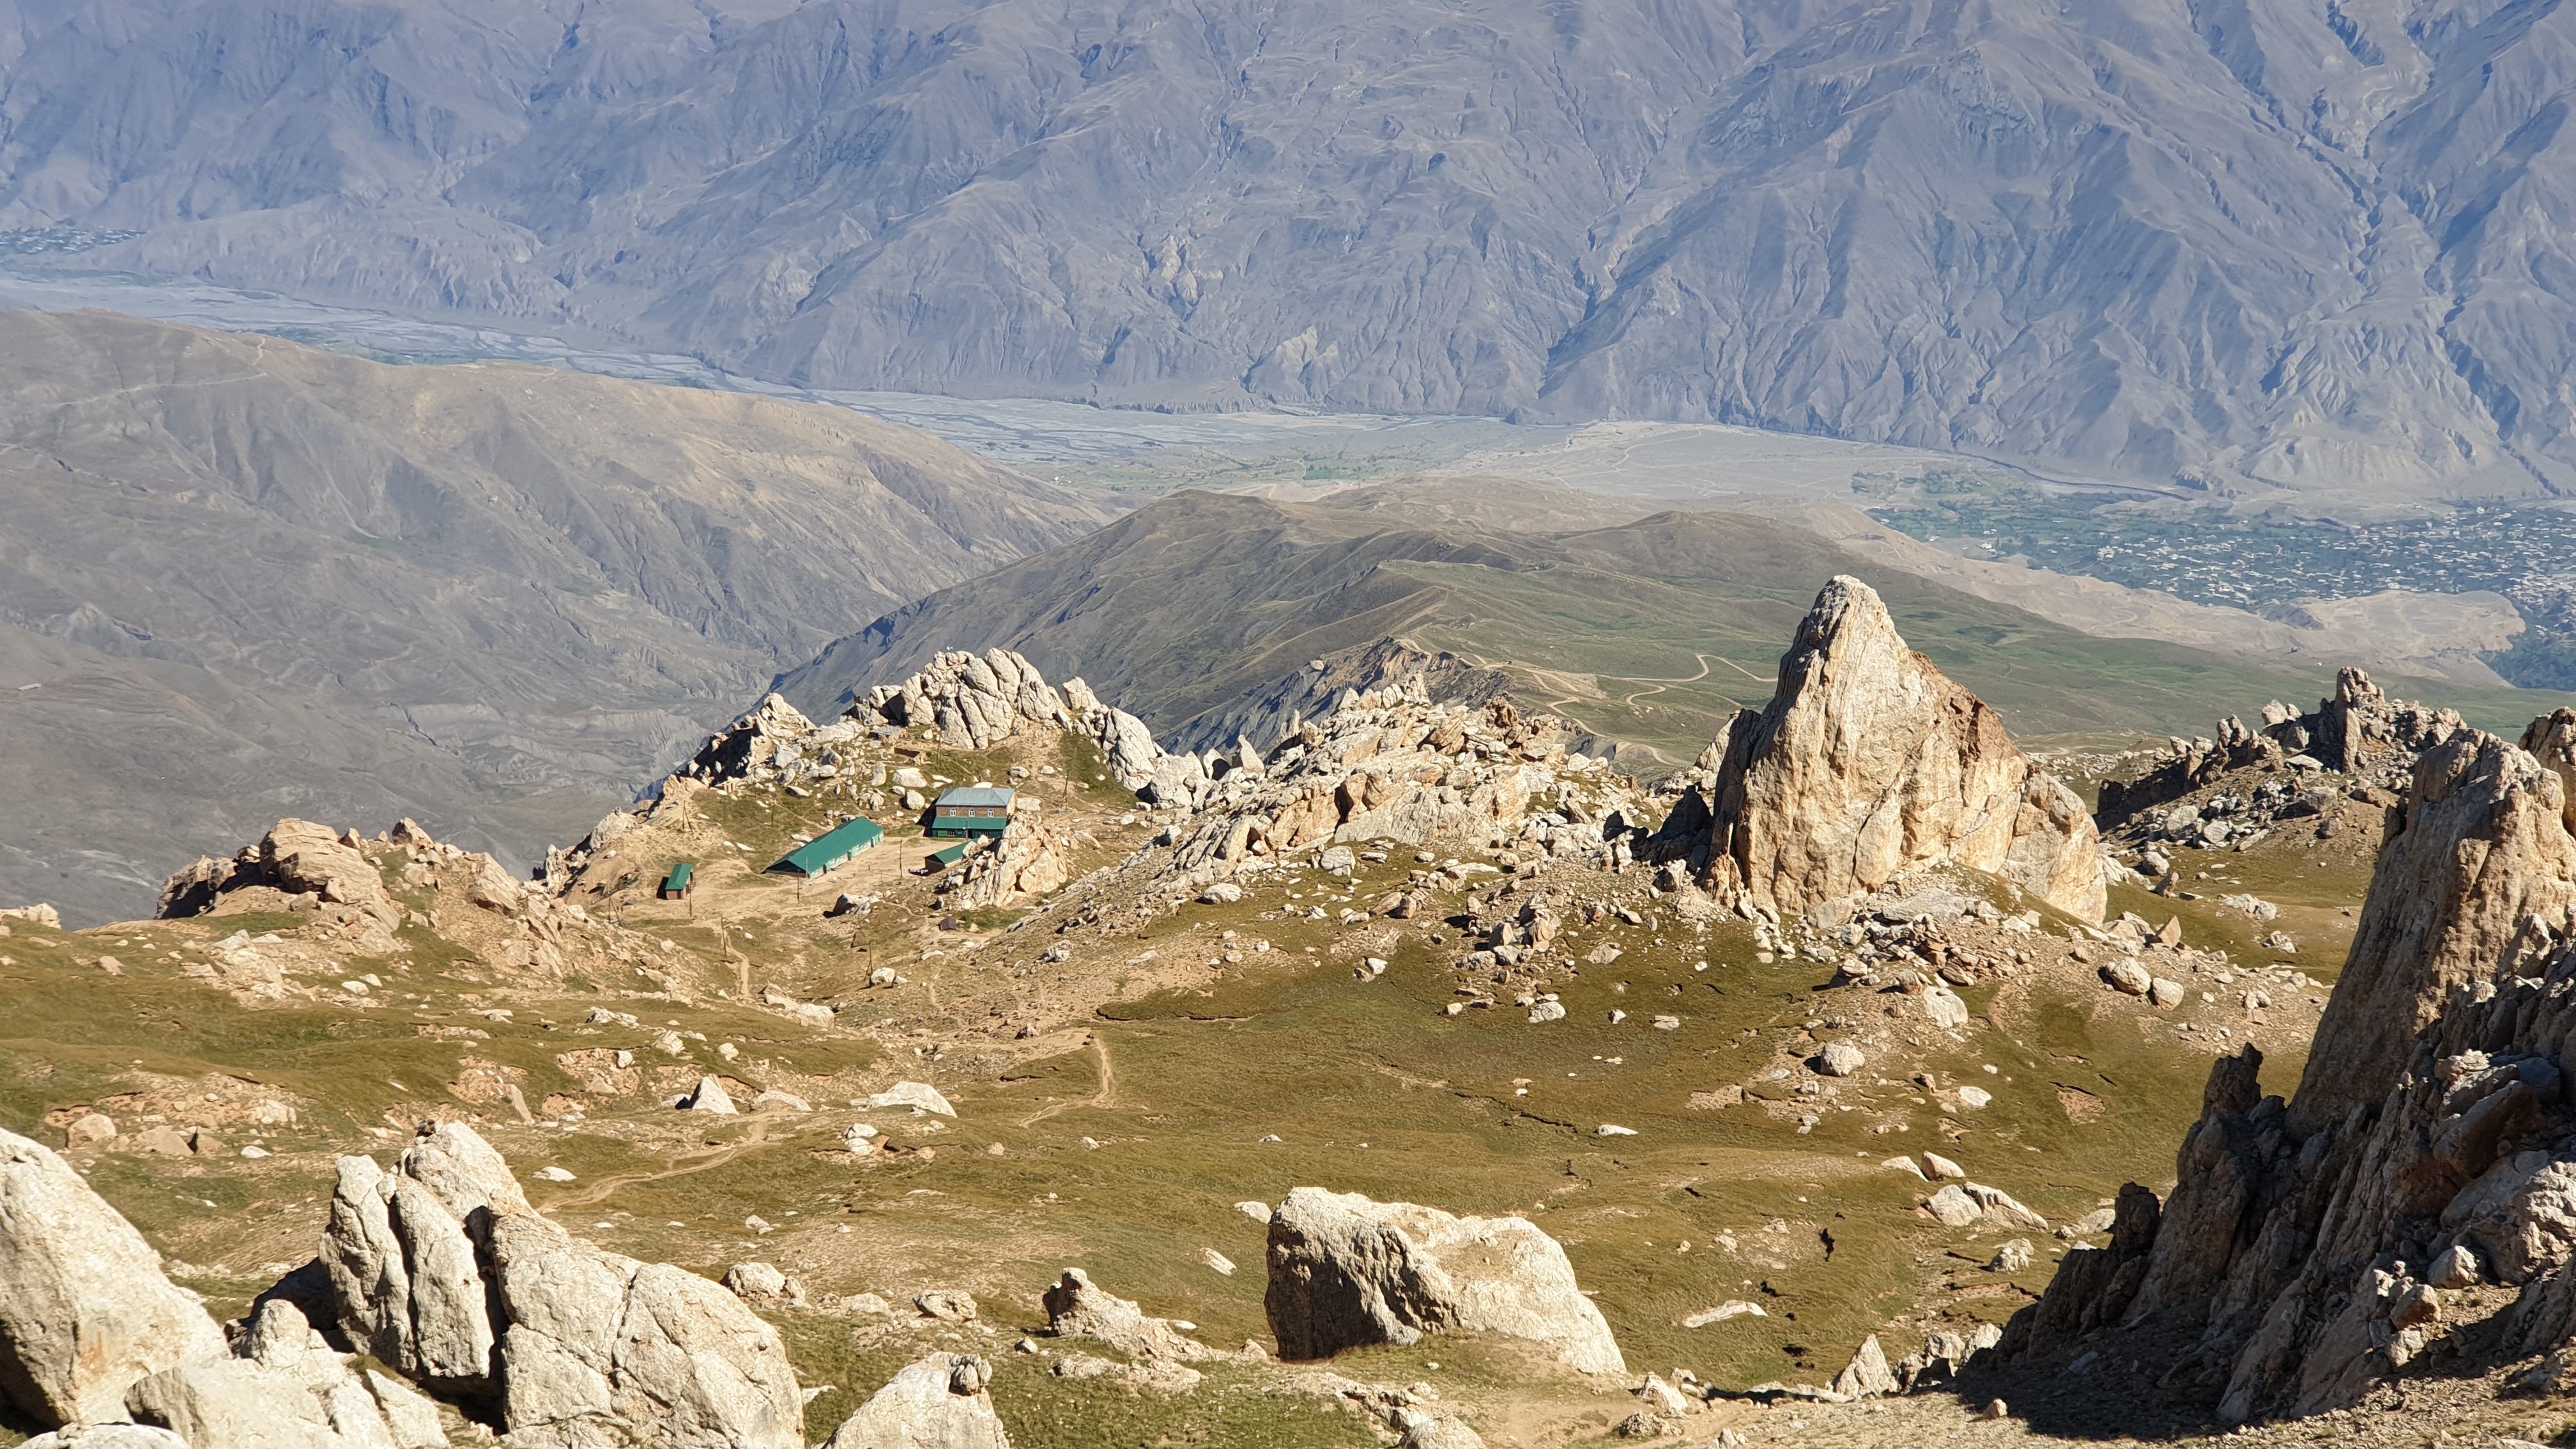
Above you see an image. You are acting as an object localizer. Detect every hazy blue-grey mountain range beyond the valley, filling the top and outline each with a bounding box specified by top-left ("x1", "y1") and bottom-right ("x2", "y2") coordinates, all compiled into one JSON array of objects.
[{"x1": 0, "y1": 0, "x2": 2576, "y2": 493}]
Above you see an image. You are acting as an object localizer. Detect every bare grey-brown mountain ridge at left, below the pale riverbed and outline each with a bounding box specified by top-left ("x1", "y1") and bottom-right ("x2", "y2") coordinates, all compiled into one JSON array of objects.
[{"x1": 0, "y1": 312, "x2": 1100, "y2": 910}]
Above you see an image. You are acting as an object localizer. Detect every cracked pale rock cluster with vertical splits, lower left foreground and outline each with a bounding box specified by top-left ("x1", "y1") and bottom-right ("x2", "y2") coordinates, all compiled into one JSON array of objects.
[{"x1": 322, "y1": 1124, "x2": 804, "y2": 1449}]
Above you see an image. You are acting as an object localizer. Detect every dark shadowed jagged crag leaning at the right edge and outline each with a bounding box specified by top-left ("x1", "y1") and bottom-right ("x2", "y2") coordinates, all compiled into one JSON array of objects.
[{"x1": 2014, "y1": 722, "x2": 2576, "y2": 1421}]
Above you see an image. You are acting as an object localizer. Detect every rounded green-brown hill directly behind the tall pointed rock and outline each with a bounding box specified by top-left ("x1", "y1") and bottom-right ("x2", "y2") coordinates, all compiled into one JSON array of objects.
[{"x1": 781, "y1": 487, "x2": 2558, "y2": 760}]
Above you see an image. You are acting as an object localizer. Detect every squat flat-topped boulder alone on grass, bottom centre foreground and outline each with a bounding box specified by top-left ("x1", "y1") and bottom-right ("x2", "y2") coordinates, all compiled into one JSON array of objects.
[{"x1": 1262, "y1": 1188, "x2": 1625, "y2": 1374}]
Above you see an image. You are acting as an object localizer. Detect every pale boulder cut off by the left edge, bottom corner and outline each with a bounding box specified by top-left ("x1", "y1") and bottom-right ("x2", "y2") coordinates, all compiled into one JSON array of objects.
[{"x1": 0, "y1": 1132, "x2": 229, "y2": 1426}]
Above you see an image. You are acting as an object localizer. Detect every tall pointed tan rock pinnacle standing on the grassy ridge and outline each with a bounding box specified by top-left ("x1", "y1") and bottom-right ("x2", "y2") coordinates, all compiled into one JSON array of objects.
[{"x1": 1667, "y1": 578, "x2": 2102, "y2": 921}]
